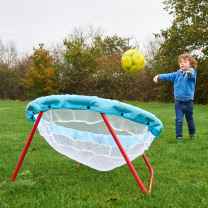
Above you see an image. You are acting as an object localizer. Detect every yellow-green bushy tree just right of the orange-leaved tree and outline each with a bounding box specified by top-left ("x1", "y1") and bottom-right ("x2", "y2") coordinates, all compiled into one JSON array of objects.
[{"x1": 63, "y1": 38, "x2": 98, "y2": 94}]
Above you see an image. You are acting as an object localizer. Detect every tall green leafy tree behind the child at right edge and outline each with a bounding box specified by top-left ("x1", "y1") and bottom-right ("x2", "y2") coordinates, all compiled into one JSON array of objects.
[{"x1": 153, "y1": 0, "x2": 208, "y2": 103}]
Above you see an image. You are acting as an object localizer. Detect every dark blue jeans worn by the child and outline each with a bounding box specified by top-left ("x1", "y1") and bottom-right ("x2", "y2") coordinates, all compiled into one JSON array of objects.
[{"x1": 175, "y1": 100, "x2": 195, "y2": 138}]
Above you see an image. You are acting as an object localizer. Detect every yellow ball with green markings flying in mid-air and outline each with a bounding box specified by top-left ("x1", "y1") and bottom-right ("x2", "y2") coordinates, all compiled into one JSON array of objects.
[{"x1": 121, "y1": 49, "x2": 145, "y2": 73}]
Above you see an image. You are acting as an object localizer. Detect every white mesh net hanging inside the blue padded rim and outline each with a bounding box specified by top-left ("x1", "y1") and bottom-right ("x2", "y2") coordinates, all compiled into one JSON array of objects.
[{"x1": 35, "y1": 109, "x2": 155, "y2": 171}]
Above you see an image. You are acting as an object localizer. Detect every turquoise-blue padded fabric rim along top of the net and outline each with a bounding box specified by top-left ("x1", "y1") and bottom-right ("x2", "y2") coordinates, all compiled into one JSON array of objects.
[{"x1": 26, "y1": 94, "x2": 163, "y2": 137}]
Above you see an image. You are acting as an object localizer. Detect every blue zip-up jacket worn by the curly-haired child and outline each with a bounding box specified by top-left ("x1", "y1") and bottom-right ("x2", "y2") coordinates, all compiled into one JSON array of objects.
[{"x1": 159, "y1": 68, "x2": 197, "y2": 101}]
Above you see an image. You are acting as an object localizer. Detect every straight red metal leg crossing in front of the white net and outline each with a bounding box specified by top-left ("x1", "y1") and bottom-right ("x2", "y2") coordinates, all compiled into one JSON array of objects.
[{"x1": 101, "y1": 113, "x2": 147, "y2": 194}]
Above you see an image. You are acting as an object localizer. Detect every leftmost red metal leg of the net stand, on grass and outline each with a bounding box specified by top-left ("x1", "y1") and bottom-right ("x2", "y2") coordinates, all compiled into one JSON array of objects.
[{"x1": 11, "y1": 111, "x2": 43, "y2": 182}]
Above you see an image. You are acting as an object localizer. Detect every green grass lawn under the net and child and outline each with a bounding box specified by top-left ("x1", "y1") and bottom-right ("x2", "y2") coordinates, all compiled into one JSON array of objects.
[{"x1": 0, "y1": 101, "x2": 208, "y2": 208}]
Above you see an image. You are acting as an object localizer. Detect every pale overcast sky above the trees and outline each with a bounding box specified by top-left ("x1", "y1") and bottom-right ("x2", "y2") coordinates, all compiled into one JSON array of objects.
[{"x1": 0, "y1": 0, "x2": 172, "y2": 53}]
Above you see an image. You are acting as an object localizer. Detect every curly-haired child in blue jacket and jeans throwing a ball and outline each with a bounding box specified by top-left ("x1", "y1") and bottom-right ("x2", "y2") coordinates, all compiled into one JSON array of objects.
[{"x1": 153, "y1": 54, "x2": 197, "y2": 144}]
